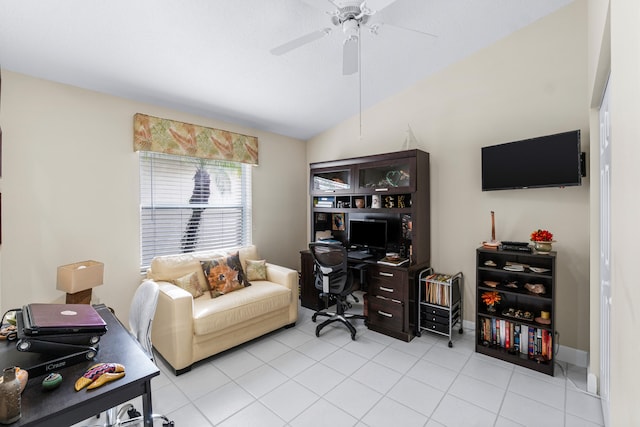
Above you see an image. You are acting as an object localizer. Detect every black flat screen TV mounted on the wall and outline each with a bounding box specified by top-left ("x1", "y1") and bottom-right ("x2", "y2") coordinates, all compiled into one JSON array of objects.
[{"x1": 482, "y1": 130, "x2": 583, "y2": 191}]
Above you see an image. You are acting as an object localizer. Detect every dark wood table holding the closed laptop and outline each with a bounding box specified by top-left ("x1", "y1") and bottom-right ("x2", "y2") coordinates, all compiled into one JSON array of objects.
[{"x1": 0, "y1": 305, "x2": 160, "y2": 427}]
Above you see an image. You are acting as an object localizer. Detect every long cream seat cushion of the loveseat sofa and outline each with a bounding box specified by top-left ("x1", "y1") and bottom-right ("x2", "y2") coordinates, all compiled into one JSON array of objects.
[{"x1": 193, "y1": 280, "x2": 291, "y2": 335}]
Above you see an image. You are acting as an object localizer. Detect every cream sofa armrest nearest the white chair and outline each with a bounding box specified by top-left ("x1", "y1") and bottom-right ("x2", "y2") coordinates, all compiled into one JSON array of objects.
[{"x1": 151, "y1": 282, "x2": 193, "y2": 370}]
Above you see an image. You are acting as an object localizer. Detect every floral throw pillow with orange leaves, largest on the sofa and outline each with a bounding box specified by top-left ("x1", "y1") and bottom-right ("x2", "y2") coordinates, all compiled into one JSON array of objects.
[{"x1": 200, "y1": 252, "x2": 251, "y2": 298}]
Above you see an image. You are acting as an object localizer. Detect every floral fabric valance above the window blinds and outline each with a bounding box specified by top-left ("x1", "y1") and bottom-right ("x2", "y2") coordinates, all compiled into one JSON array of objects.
[{"x1": 133, "y1": 113, "x2": 258, "y2": 165}]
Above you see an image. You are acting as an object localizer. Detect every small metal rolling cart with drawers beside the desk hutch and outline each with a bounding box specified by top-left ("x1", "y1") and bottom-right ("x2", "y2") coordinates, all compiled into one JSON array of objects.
[{"x1": 417, "y1": 268, "x2": 463, "y2": 347}]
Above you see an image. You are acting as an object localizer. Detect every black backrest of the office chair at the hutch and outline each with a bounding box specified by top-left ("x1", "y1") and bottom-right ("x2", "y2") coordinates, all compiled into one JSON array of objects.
[{"x1": 309, "y1": 242, "x2": 351, "y2": 294}]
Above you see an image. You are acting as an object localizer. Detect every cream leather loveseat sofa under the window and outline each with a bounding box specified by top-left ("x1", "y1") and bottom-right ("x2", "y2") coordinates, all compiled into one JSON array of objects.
[{"x1": 147, "y1": 246, "x2": 298, "y2": 375}]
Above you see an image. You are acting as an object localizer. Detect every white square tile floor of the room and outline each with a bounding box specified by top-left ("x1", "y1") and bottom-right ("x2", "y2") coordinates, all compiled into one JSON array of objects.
[{"x1": 76, "y1": 298, "x2": 603, "y2": 427}]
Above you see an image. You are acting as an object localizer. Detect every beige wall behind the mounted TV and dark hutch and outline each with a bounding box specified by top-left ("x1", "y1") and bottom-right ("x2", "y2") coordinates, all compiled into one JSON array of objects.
[{"x1": 307, "y1": 2, "x2": 591, "y2": 352}]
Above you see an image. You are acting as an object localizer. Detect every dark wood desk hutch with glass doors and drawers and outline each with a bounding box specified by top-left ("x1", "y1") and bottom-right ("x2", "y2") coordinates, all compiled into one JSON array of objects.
[{"x1": 301, "y1": 150, "x2": 431, "y2": 341}]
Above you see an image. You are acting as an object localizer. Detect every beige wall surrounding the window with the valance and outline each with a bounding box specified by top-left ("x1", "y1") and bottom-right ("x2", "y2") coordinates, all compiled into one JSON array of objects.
[{"x1": 0, "y1": 70, "x2": 307, "y2": 321}]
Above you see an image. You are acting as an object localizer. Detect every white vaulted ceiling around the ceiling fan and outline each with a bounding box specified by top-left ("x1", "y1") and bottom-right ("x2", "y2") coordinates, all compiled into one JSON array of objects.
[{"x1": 0, "y1": 0, "x2": 573, "y2": 140}]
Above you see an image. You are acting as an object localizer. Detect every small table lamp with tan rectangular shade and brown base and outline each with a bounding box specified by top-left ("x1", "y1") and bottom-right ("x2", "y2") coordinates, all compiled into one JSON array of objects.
[{"x1": 56, "y1": 261, "x2": 104, "y2": 304}]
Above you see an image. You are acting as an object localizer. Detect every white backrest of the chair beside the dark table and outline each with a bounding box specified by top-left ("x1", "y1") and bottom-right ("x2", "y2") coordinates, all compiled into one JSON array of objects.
[{"x1": 129, "y1": 280, "x2": 160, "y2": 359}]
